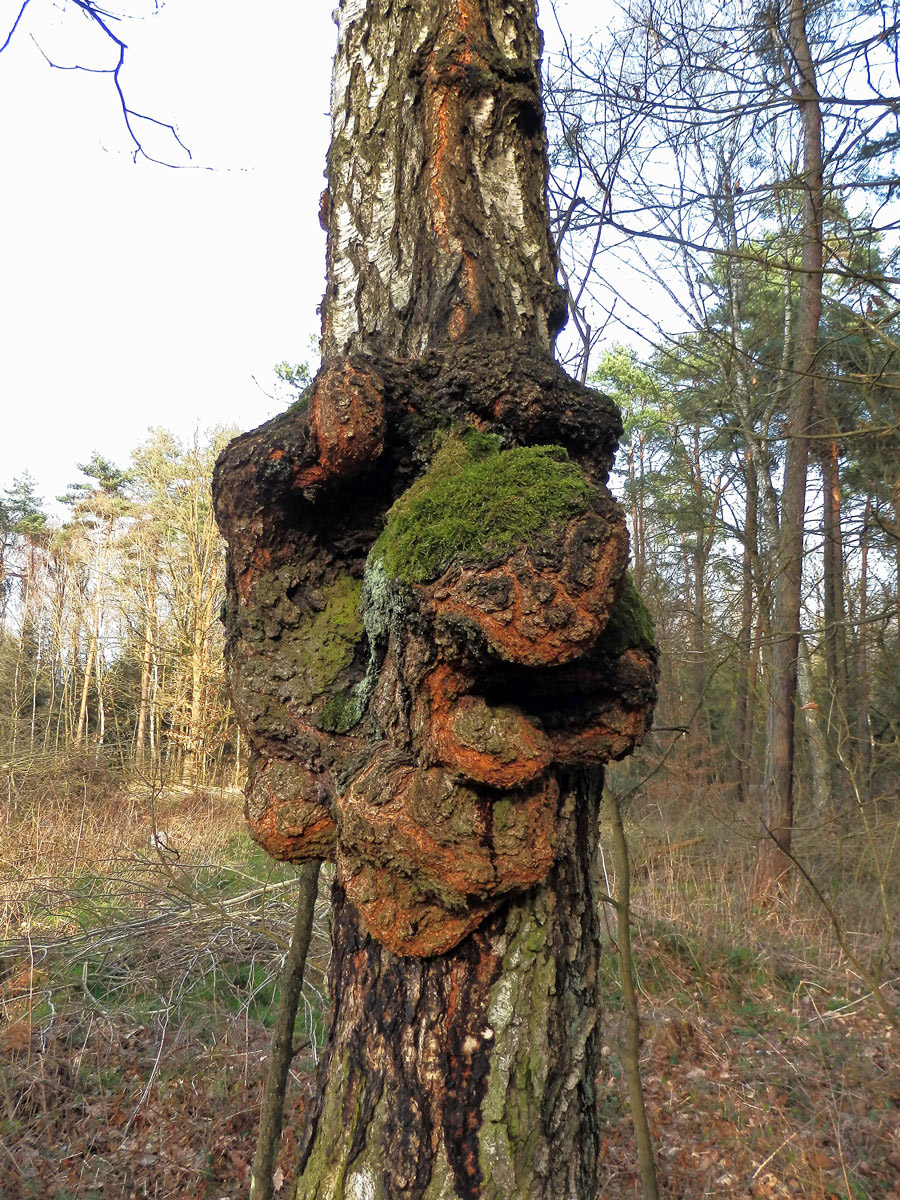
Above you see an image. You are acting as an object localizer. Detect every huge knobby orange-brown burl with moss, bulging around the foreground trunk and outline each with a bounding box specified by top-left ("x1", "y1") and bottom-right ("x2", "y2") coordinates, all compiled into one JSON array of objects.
[{"x1": 218, "y1": 342, "x2": 655, "y2": 955}]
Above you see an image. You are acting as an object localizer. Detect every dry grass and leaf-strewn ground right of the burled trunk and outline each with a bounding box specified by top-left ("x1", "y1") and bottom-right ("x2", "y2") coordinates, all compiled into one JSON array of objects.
[{"x1": 592, "y1": 763, "x2": 900, "y2": 1200}]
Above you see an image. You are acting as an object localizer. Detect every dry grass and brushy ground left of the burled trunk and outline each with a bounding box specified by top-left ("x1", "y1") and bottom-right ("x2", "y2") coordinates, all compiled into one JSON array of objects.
[{"x1": 0, "y1": 763, "x2": 329, "y2": 1200}]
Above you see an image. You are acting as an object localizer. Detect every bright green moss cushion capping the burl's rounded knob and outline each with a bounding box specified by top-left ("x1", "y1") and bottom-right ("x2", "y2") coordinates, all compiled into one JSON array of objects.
[{"x1": 372, "y1": 430, "x2": 592, "y2": 583}]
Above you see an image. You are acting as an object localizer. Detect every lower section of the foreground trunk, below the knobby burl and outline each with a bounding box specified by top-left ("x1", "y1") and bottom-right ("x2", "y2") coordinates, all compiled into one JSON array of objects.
[{"x1": 294, "y1": 776, "x2": 602, "y2": 1200}]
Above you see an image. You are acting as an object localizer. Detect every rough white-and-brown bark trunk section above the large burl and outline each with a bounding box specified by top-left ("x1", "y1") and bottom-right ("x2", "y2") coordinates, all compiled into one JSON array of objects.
[{"x1": 322, "y1": 0, "x2": 565, "y2": 358}]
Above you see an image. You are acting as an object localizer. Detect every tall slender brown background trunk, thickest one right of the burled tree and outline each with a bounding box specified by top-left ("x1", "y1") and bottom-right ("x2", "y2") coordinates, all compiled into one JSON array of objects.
[{"x1": 755, "y1": 0, "x2": 823, "y2": 898}]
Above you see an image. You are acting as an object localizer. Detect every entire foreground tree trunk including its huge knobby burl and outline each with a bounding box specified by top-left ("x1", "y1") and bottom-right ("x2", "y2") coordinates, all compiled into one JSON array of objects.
[{"x1": 214, "y1": 0, "x2": 656, "y2": 1200}]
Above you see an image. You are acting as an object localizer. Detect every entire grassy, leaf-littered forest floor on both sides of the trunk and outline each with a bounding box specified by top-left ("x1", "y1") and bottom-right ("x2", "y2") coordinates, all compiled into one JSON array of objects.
[{"x1": 0, "y1": 772, "x2": 900, "y2": 1200}]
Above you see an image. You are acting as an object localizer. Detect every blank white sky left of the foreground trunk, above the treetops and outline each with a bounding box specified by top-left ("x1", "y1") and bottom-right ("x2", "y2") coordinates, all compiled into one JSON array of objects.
[{"x1": 0, "y1": 0, "x2": 596, "y2": 499}]
